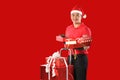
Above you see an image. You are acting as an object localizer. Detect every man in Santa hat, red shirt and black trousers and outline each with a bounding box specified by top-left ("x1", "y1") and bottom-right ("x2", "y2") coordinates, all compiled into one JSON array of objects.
[{"x1": 56, "y1": 6, "x2": 91, "y2": 80}]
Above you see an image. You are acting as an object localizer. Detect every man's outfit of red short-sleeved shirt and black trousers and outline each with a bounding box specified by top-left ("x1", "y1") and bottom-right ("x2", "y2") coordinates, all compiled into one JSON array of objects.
[{"x1": 65, "y1": 23, "x2": 91, "y2": 80}]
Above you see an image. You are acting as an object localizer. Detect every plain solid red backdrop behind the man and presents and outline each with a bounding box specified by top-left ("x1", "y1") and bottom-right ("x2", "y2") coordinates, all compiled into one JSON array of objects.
[{"x1": 0, "y1": 0, "x2": 120, "y2": 80}]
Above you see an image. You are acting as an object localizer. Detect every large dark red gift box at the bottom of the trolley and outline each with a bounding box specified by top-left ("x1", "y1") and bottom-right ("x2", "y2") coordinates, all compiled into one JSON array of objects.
[{"x1": 40, "y1": 65, "x2": 74, "y2": 80}]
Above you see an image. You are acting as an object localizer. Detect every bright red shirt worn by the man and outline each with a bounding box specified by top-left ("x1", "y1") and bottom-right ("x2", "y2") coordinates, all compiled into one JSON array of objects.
[{"x1": 65, "y1": 23, "x2": 91, "y2": 53}]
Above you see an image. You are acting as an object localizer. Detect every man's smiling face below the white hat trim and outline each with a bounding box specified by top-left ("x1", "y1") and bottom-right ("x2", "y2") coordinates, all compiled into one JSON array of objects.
[{"x1": 71, "y1": 12, "x2": 82, "y2": 24}]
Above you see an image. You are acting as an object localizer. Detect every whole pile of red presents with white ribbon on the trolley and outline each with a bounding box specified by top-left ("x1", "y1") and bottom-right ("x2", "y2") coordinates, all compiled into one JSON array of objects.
[{"x1": 40, "y1": 48, "x2": 74, "y2": 80}]
